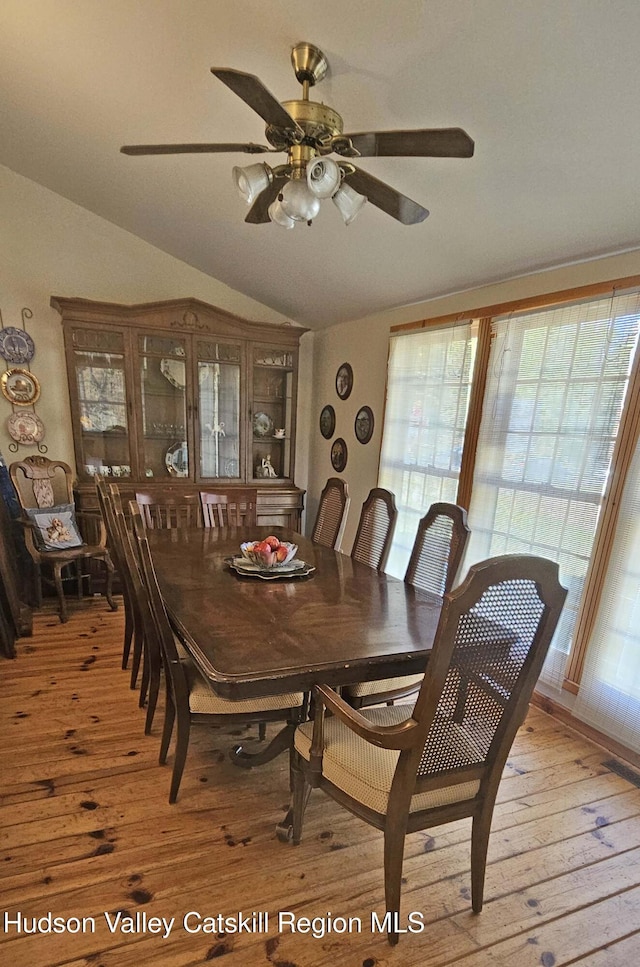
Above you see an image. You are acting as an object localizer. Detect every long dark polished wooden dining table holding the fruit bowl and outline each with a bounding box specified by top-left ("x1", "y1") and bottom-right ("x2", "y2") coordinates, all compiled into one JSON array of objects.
[{"x1": 148, "y1": 525, "x2": 442, "y2": 765}]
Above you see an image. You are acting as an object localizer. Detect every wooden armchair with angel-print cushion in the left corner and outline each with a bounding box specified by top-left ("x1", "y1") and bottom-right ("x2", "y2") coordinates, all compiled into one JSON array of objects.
[{"x1": 9, "y1": 455, "x2": 118, "y2": 622}]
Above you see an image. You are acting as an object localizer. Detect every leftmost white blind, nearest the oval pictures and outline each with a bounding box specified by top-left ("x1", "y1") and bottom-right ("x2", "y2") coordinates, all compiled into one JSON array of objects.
[{"x1": 378, "y1": 323, "x2": 476, "y2": 578}]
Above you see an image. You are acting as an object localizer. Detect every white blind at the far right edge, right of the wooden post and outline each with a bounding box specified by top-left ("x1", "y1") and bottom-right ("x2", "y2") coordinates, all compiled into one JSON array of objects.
[{"x1": 573, "y1": 441, "x2": 640, "y2": 752}]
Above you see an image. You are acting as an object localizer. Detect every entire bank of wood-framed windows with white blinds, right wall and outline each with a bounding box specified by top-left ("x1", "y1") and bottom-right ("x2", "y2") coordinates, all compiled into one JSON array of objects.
[{"x1": 380, "y1": 278, "x2": 640, "y2": 751}]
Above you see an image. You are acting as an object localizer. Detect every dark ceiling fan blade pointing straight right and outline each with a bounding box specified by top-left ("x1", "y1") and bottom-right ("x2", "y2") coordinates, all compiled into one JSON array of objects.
[{"x1": 341, "y1": 128, "x2": 474, "y2": 158}]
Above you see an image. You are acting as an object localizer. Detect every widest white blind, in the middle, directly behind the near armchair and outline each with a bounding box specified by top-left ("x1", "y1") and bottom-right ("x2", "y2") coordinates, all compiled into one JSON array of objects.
[{"x1": 465, "y1": 292, "x2": 640, "y2": 687}]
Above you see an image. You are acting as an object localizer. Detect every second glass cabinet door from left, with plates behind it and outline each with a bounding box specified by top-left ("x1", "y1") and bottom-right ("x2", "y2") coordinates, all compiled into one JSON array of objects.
[{"x1": 138, "y1": 334, "x2": 191, "y2": 480}]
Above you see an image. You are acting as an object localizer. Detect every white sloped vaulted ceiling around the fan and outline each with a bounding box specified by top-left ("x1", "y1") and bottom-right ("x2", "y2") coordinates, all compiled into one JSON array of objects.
[{"x1": 0, "y1": 0, "x2": 640, "y2": 328}]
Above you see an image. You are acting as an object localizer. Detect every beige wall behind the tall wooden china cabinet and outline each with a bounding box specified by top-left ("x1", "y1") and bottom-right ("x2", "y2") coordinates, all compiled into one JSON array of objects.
[{"x1": 0, "y1": 167, "x2": 310, "y2": 484}]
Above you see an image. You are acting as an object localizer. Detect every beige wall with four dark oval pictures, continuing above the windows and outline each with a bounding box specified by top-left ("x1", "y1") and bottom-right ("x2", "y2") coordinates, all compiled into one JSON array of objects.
[{"x1": 307, "y1": 250, "x2": 640, "y2": 553}]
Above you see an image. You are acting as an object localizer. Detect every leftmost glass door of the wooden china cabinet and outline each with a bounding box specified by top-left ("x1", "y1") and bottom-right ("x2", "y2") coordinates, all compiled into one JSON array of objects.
[{"x1": 72, "y1": 329, "x2": 132, "y2": 477}]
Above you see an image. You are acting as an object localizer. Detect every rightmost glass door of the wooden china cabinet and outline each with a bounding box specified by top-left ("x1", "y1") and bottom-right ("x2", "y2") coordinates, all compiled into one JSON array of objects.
[{"x1": 250, "y1": 346, "x2": 294, "y2": 480}]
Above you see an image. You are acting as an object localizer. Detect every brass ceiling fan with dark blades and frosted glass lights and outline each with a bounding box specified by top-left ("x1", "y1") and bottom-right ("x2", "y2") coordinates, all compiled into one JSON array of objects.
[{"x1": 120, "y1": 43, "x2": 474, "y2": 228}]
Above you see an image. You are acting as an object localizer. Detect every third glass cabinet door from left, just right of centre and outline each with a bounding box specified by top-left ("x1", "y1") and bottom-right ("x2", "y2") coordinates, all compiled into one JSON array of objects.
[{"x1": 196, "y1": 339, "x2": 243, "y2": 480}]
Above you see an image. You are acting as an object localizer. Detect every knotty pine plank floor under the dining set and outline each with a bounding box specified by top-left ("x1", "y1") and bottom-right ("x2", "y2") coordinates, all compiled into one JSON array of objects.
[{"x1": 0, "y1": 599, "x2": 640, "y2": 967}]
